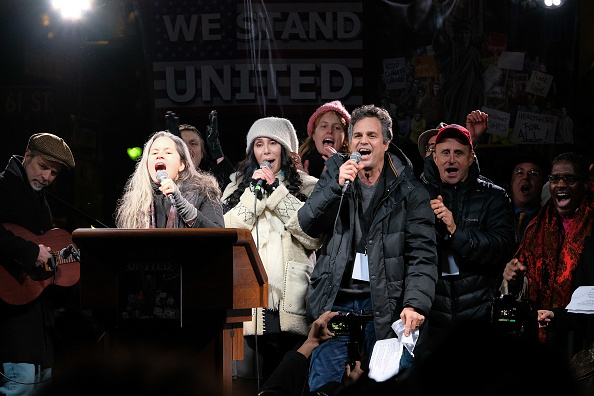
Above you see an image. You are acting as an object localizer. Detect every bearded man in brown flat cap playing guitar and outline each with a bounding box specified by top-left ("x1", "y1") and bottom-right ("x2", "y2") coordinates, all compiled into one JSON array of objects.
[{"x1": 0, "y1": 133, "x2": 74, "y2": 396}]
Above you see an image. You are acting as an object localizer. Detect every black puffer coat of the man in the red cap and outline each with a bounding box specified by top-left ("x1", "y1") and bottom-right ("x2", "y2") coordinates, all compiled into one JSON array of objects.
[{"x1": 422, "y1": 153, "x2": 515, "y2": 331}]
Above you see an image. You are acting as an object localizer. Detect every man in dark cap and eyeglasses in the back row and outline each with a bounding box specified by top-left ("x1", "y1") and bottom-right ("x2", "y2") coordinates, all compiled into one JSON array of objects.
[{"x1": 510, "y1": 153, "x2": 545, "y2": 243}]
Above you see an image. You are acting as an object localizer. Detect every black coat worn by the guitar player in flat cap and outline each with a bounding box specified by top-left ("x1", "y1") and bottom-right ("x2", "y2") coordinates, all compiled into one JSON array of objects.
[{"x1": 0, "y1": 156, "x2": 54, "y2": 367}]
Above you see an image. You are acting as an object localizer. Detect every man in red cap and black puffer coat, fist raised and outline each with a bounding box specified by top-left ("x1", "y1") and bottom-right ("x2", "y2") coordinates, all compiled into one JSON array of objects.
[{"x1": 424, "y1": 124, "x2": 515, "y2": 339}]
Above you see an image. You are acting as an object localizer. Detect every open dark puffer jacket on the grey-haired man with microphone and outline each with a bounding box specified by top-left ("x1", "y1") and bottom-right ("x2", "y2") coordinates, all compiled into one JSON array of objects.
[{"x1": 298, "y1": 150, "x2": 437, "y2": 340}]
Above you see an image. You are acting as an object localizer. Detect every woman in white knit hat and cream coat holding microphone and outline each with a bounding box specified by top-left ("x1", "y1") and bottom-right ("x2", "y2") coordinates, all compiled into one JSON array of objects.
[{"x1": 222, "y1": 117, "x2": 320, "y2": 378}]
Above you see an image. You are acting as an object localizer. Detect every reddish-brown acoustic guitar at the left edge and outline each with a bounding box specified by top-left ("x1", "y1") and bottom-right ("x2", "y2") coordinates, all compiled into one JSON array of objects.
[{"x1": 0, "y1": 224, "x2": 80, "y2": 305}]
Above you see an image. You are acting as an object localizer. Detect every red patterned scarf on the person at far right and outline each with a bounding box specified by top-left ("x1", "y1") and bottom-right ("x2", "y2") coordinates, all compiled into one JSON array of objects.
[{"x1": 515, "y1": 192, "x2": 594, "y2": 310}]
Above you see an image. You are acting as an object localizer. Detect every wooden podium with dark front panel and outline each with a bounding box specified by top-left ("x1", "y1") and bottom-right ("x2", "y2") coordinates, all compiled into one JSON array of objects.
[{"x1": 72, "y1": 228, "x2": 268, "y2": 396}]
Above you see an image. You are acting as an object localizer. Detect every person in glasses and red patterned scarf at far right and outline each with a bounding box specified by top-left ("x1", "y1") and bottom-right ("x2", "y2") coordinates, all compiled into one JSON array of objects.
[{"x1": 502, "y1": 152, "x2": 594, "y2": 358}]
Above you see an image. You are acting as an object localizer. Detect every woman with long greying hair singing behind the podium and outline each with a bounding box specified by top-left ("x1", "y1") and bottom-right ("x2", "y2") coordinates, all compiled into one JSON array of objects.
[{"x1": 116, "y1": 131, "x2": 224, "y2": 228}]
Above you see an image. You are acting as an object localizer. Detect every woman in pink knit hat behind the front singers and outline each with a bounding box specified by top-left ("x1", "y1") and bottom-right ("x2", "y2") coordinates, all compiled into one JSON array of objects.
[{"x1": 299, "y1": 100, "x2": 351, "y2": 178}]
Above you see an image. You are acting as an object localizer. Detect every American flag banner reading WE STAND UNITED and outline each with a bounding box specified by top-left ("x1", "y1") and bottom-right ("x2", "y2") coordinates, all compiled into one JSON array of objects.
[{"x1": 148, "y1": 0, "x2": 363, "y2": 114}]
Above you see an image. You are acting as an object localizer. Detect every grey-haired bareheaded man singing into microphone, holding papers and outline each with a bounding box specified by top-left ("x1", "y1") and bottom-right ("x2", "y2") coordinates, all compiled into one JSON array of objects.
[{"x1": 298, "y1": 105, "x2": 437, "y2": 391}]
